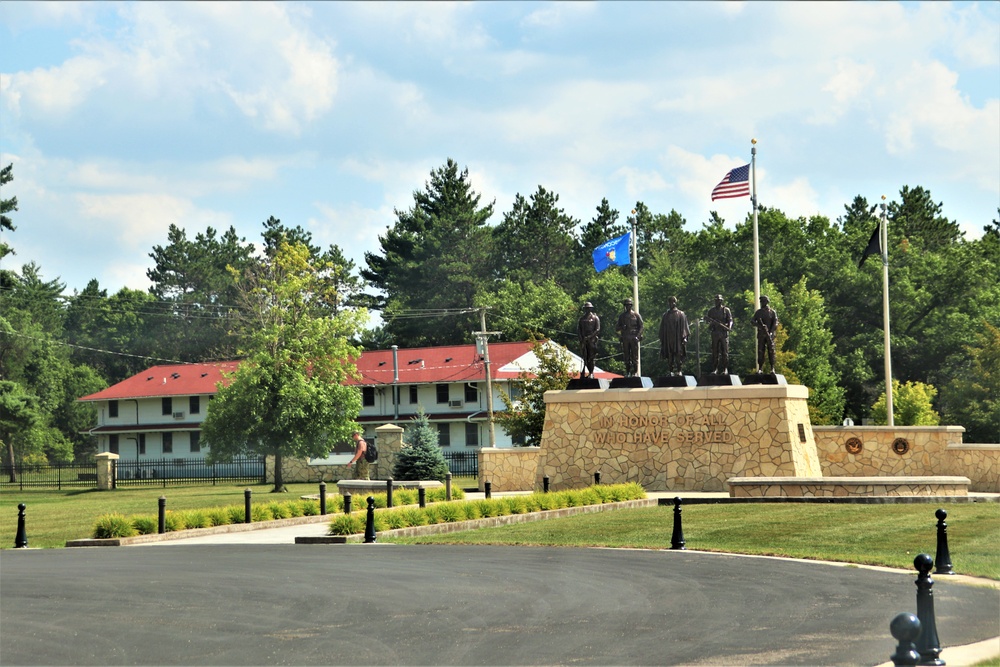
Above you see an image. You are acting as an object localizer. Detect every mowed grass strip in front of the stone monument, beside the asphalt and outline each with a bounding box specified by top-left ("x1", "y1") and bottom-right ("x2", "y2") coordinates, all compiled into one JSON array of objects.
[{"x1": 379, "y1": 503, "x2": 1000, "y2": 579}]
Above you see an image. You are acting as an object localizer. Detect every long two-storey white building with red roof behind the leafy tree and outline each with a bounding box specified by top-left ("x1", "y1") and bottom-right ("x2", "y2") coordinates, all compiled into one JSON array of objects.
[{"x1": 79, "y1": 342, "x2": 618, "y2": 463}]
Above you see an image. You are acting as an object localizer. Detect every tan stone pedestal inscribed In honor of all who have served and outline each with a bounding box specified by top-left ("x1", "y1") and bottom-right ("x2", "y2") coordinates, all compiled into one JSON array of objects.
[{"x1": 535, "y1": 385, "x2": 822, "y2": 491}]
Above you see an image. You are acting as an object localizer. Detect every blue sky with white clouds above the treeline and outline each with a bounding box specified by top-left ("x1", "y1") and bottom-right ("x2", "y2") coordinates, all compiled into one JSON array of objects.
[{"x1": 0, "y1": 2, "x2": 1000, "y2": 292}]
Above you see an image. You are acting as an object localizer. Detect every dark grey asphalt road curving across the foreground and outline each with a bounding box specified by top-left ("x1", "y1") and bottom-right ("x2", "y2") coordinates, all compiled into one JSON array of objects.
[{"x1": 0, "y1": 544, "x2": 1000, "y2": 666}]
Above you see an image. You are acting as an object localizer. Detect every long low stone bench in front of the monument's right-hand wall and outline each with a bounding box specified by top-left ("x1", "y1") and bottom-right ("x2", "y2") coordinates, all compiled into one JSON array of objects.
[{"x1": 726, "y1": 476, "x2": 971, "y2": 498}]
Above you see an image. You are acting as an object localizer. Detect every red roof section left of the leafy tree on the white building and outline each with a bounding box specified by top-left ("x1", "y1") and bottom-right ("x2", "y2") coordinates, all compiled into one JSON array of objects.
[{"x1": 79, "y1": 361, "x2": 240, "y2": 401}]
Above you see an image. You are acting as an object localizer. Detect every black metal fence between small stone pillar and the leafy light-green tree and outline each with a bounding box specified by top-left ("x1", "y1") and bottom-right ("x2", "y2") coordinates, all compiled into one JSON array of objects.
[{"x1": 114, "y1": 457, "x2": 267, "y2": 486}]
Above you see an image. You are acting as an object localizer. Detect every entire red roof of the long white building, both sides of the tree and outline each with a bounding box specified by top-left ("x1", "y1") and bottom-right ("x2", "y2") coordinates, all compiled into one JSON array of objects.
[{"x1": 79, "y1": 342, "x2": 619, "y2": 401}]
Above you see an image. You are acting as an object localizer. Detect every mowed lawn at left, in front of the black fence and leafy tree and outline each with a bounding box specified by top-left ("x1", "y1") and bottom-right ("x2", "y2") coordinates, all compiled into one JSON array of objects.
[{"x1": 0, "y1": 482, "x2": 326, "y2": 549}]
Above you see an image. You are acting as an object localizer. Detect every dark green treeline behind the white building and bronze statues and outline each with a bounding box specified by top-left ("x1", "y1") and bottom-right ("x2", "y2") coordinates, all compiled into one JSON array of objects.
[{"x1": 0, "y1": 160, "x2": 1000, "y2": 462}]
